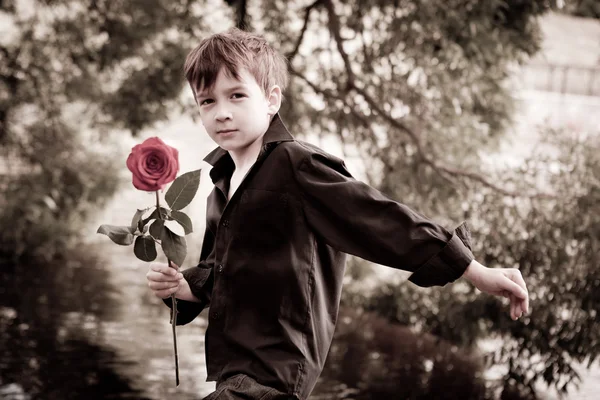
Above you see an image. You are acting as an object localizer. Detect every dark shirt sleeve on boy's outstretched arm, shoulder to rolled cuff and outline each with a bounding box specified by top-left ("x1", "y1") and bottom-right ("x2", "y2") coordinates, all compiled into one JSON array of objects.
[{"x1": 295, "y1": 149, "x2": 473, "y2": 287}]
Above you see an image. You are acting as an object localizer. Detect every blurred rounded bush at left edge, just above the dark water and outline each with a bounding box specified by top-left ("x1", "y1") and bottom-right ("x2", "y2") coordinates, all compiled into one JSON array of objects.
[{"x1": 0, "y1": 124, "x2": 118, "y2": 260}]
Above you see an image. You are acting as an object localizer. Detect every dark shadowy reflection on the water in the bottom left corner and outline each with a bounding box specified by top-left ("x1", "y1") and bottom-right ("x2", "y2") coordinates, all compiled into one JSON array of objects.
[{"x1": 0, "y1": 245, "x2": 146, "y2": 400}]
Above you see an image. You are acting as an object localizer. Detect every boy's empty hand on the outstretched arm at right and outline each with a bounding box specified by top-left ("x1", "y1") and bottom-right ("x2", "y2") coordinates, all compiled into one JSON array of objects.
[{"x1": 463, "y1": 260, "x2": 529, "y2": 320}]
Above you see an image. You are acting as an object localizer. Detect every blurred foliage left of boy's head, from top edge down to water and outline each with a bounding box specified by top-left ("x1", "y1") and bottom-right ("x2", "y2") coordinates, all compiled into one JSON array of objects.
[{"x1": 0, "y1": 0, "x2": 225, "y2": 258}]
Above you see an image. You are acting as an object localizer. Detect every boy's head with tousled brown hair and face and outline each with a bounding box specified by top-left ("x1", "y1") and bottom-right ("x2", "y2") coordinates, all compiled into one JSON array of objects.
[{"x1": 184, "y1": 28, "x2": 289, "y2": 152}]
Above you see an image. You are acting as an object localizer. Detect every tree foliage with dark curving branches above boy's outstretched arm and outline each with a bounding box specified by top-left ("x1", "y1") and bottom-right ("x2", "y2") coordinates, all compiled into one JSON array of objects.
[{"x1": 257, "y1": 0, "x2": 564, "y2": 220}]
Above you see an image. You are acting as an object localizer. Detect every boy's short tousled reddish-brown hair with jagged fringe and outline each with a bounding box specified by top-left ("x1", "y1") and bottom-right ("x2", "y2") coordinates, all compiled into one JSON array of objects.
[{"x1": 184, "y1": 28, "x2": 289, "y2": 97}]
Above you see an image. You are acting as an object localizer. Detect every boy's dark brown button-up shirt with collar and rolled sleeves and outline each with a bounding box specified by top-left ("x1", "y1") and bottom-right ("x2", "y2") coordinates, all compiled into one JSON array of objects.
[{"x1": 166, "y1": 115, "x2": 473, "y2": 399}]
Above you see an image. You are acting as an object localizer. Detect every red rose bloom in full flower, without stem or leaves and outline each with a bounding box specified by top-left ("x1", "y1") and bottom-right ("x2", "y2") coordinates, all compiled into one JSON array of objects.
[{"x1": 127, "y1": 137, "x2": 179, "y2": 192}]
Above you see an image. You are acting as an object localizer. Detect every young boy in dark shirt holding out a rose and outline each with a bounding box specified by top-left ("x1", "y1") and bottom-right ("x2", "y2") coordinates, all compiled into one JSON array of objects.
[{"x1": 147, "y1": 29, "x2": 528, "y2": 400}]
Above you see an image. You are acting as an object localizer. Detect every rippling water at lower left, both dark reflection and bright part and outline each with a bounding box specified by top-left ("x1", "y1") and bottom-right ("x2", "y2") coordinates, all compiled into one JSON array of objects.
[{"x1": 0, "y1": 245, "x2": 212, "y2": 400}]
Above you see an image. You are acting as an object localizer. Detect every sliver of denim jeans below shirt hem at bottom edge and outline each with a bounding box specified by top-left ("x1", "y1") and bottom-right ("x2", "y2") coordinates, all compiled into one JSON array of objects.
[{"x1": 203, "y1": 374, "x2": 295, "y2": 400}]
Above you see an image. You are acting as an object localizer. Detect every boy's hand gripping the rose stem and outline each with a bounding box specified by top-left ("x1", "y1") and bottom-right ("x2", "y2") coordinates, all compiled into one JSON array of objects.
[{"x1": 146, "y1": 261, "x2": 197, "y2": 301}]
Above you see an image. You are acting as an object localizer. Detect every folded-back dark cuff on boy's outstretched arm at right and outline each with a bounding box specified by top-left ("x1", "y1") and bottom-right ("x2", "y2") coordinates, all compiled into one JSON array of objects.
[{"x1": 408, "y1": 222, "x2": 475, "y2": 287}]
